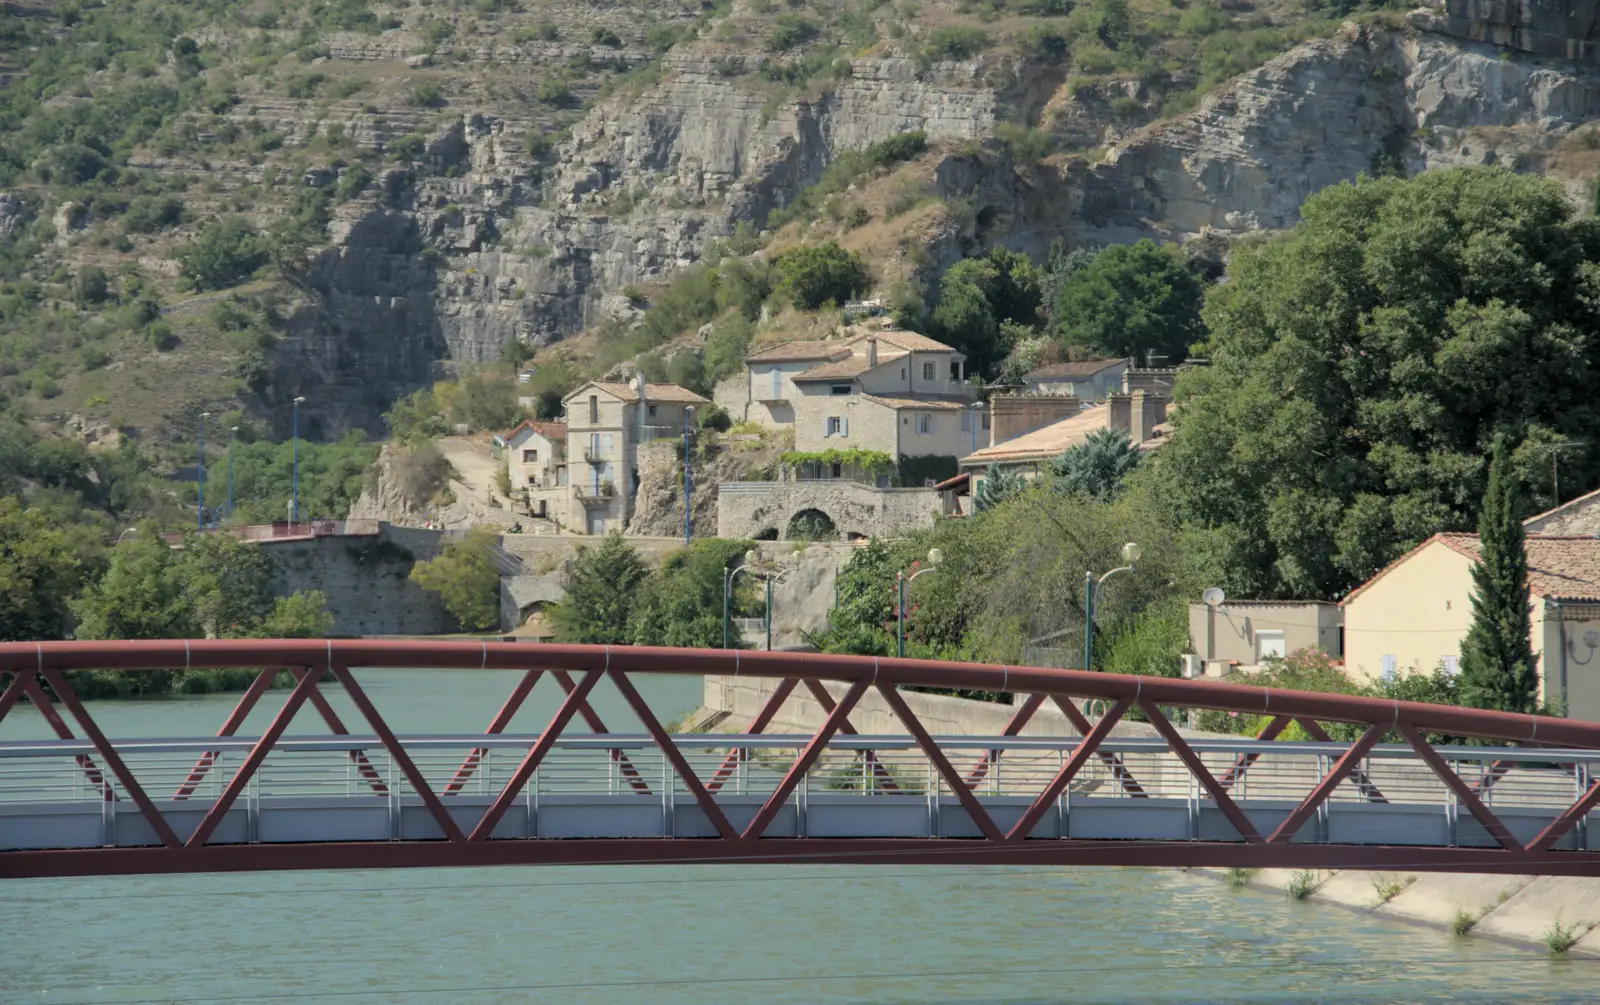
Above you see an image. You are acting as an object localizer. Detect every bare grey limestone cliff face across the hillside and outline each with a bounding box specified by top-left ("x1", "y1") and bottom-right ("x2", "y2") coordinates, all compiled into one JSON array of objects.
[{"x1": 294, "y1": 26, "x2": 1600, "y2": 432}]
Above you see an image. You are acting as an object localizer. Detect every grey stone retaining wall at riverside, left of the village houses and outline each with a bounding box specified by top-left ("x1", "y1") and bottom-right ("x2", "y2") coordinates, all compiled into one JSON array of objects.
[{"x1": 259, "y1": 523, "x2": 456, "y2": 635}]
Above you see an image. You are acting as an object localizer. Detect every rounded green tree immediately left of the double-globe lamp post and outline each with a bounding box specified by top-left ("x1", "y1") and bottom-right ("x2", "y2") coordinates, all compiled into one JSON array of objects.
[{"x1": 627, "y1": 539, "x2": 750, "y2": 648}]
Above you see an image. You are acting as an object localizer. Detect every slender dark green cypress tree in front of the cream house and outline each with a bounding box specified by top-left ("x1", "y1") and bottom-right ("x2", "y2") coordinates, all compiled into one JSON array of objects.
[{"x1": 1461, "y1": 437, "x2": 1539, "y2": 712}]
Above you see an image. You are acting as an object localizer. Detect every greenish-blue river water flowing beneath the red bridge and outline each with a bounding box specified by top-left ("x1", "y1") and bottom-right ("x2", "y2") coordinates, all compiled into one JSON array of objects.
[{"x1": 0, "y1": 671, "x2": 1600, "y2": 1005}]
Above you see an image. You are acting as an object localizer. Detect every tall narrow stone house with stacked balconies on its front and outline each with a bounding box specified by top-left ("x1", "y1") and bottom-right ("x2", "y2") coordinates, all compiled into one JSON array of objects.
[{"x1": 562, "y1": 378, "x2": 710, "y2": 535}]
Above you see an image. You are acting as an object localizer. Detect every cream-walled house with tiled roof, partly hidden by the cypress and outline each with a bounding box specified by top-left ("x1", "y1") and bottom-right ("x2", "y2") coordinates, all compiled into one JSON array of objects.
[{"x1": 1339, "y1": 533, "x2": 1600, "y2": 722}]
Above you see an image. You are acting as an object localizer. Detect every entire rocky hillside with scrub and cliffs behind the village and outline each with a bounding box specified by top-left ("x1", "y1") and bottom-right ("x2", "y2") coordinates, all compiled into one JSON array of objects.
[{"x1": 0, "y1": 0, "x2": 1600, "y2": 448}]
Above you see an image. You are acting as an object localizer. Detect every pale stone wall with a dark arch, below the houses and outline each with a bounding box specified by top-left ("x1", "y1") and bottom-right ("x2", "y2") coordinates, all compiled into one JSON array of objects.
[{"x1": 717, "y1": 480, "x2": 954, "y2": 541}]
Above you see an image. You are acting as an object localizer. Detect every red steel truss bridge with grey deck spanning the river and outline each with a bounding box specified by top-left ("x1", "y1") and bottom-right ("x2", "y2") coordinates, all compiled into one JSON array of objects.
[{"x1": 0, "y1": 640, "x2": 1600, "y2": 877}]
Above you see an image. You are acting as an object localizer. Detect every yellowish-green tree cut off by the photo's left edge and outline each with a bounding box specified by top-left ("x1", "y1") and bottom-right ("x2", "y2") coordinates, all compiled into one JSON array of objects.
[{"x1": 0, "y1": 496, "x2": 102, "y2": 642}]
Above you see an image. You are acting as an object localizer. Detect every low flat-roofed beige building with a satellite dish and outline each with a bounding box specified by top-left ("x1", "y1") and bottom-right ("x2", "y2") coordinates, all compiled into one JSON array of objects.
[{"x1": 1189, "y1": 600, "x2": 1344, "y2": 675}]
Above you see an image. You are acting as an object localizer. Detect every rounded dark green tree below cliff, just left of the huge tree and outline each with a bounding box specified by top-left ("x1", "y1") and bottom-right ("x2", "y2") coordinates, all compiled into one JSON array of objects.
[{"x1": 1054, "y1": 238, "x2": 1205, "y2": 363}]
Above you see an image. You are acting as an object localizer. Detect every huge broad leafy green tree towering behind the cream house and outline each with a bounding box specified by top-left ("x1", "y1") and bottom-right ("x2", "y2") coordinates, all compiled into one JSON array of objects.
[{"x1": 1158, "y1": 168, "x2": 1600, "y2": 599}]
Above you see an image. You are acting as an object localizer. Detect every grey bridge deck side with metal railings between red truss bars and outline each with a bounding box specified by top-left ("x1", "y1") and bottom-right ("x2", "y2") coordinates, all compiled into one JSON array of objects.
[{"x1": 0, "y1": 735, "x2": 1600, "y2": 853}]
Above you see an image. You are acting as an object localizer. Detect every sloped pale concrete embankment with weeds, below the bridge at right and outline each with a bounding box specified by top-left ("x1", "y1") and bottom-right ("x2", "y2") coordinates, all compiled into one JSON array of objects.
[{"x1": 1197, "y1": 869, "x2": 1600, "y2": 957}]
